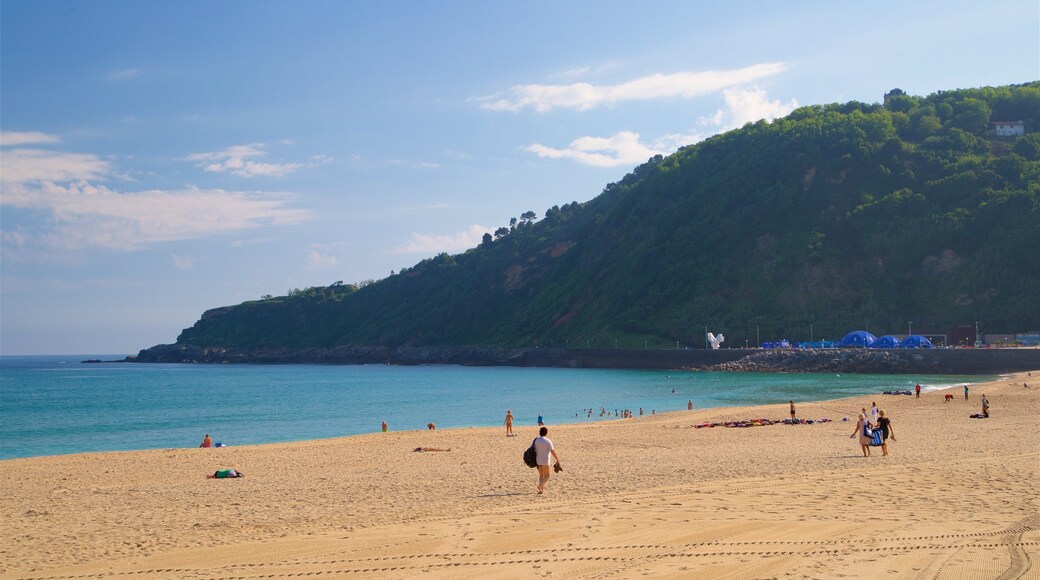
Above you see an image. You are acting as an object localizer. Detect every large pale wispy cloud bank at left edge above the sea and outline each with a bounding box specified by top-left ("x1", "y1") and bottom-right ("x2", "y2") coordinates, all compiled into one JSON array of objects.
[{"x1": 0, "y1": 138, "x2": 310, "y2": 254}]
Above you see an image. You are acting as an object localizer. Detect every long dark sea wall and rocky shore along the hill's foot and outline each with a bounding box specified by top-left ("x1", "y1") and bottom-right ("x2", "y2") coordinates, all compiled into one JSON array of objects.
[{"x1": 127, "y1": 344, "x2": 1040, "y2": 374}]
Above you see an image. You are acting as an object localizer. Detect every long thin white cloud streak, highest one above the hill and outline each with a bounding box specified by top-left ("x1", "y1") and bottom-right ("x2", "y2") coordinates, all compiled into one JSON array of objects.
[{"x1": 478, "y1": 62, "x2": 787, "y2": 112}]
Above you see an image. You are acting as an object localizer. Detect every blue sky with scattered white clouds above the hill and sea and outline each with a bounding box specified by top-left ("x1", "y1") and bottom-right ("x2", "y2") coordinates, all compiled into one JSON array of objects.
[{"x1": 6, "y1": 0, "x2": 1040, "y2": 355}]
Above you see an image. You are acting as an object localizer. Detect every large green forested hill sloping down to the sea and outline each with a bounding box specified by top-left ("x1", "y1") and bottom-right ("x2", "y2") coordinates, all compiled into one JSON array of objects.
[{"x1": 150, "y1": 82, "x2": 1040, "y2": 349}]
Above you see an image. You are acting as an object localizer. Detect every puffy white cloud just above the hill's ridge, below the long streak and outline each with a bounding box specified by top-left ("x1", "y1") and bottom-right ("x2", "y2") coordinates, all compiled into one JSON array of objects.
[{"x1": 525, "y1": 87, "x2": 798, "y2": 167}]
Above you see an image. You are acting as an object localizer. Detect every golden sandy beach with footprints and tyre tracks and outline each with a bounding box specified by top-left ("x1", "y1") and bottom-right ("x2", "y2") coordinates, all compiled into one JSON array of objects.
[{"x1": 0, "y1": 371, "x2": 1040, "y2": 578}]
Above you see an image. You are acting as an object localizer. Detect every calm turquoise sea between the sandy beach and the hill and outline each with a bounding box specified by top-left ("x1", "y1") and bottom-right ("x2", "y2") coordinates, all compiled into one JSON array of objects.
[{"x1": 0, "y1": 354, "x2": 995, "y2": 459}]
